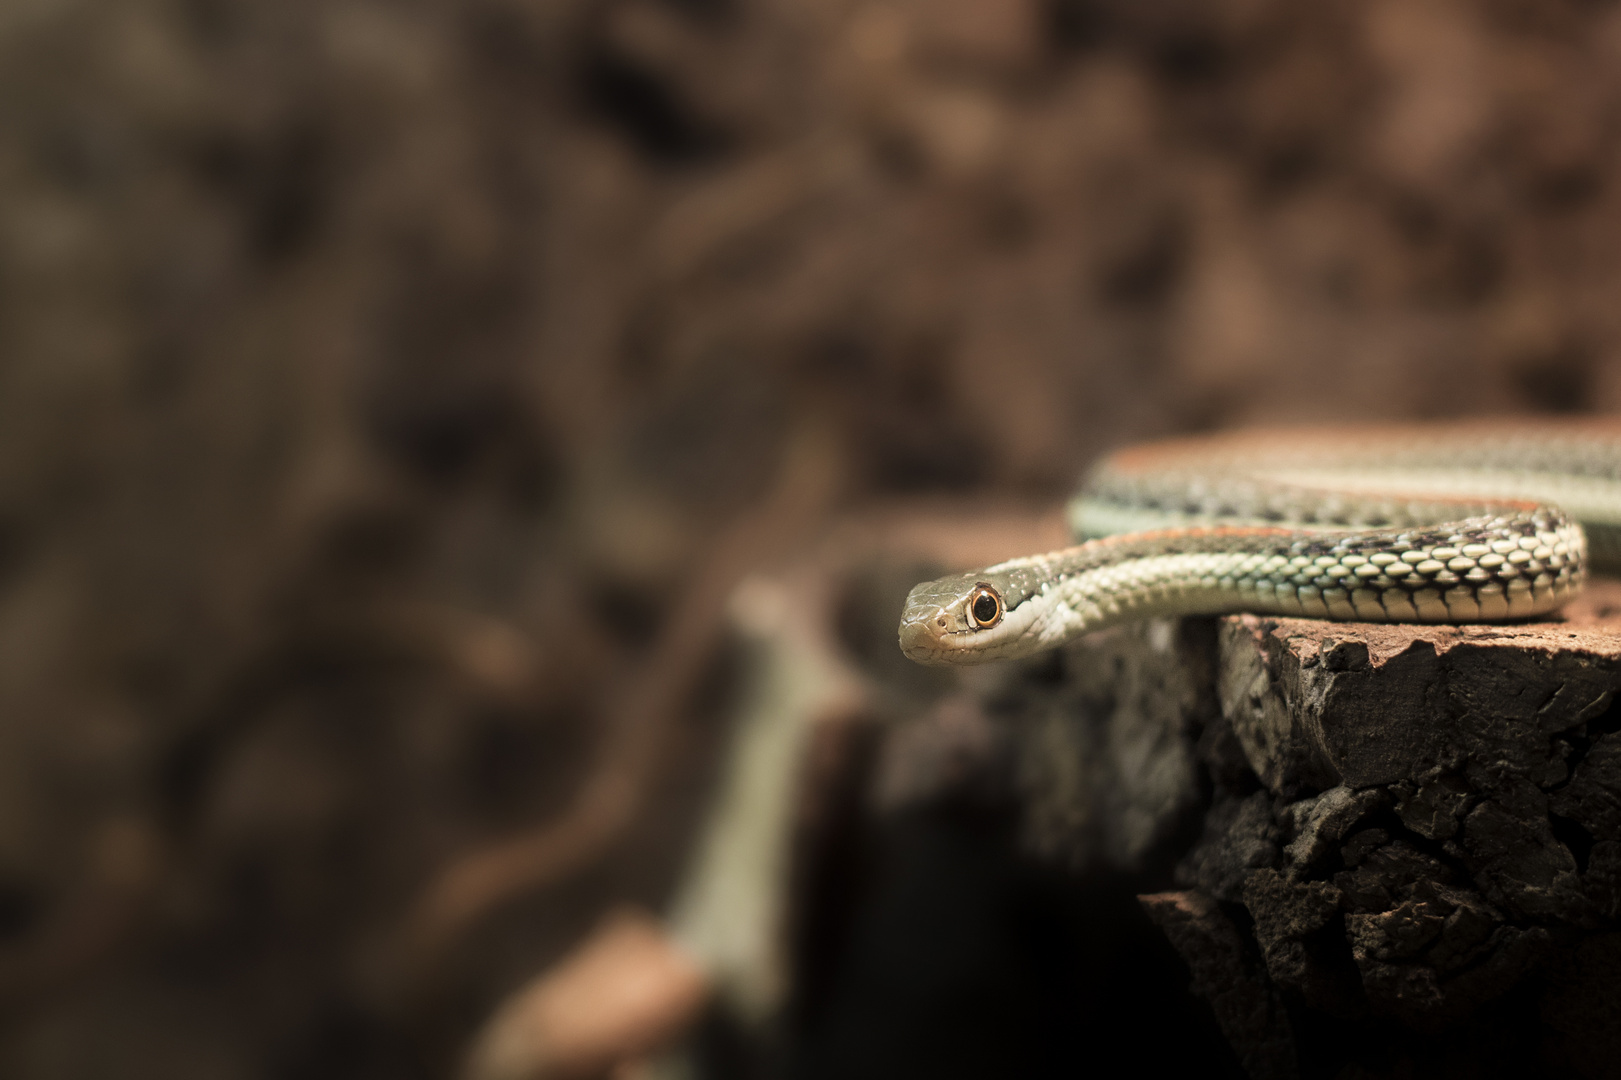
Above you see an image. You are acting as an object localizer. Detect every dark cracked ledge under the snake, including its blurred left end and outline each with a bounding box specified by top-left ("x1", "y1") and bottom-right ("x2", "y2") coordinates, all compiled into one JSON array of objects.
[{"x1": 989, "y1": 582, "x2": 1621, "y2": 1077}]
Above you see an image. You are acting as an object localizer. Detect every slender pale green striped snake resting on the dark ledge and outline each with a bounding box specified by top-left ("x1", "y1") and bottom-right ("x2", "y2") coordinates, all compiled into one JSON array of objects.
[{"x1": 900, "y1": 418, "x2": 1621, "y2": 665}]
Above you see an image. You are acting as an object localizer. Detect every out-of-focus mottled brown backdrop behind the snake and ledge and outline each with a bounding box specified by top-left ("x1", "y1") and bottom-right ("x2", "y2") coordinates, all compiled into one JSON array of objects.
[{"x1": 0, "y1": 0, "x2": 1621, "y2": 1078}]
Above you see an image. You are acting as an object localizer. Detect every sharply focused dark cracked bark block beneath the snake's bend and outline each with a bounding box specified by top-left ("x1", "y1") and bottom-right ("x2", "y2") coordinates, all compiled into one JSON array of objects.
[{"x1": 1144, "y1": 585, "x2": 1621, "y2": 1077}]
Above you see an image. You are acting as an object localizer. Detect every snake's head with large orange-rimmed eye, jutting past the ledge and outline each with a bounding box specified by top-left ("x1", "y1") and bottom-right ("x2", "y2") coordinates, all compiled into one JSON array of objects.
[{"x1": 900, "y1": 569, "x2": 1036, "y2": 663}]
